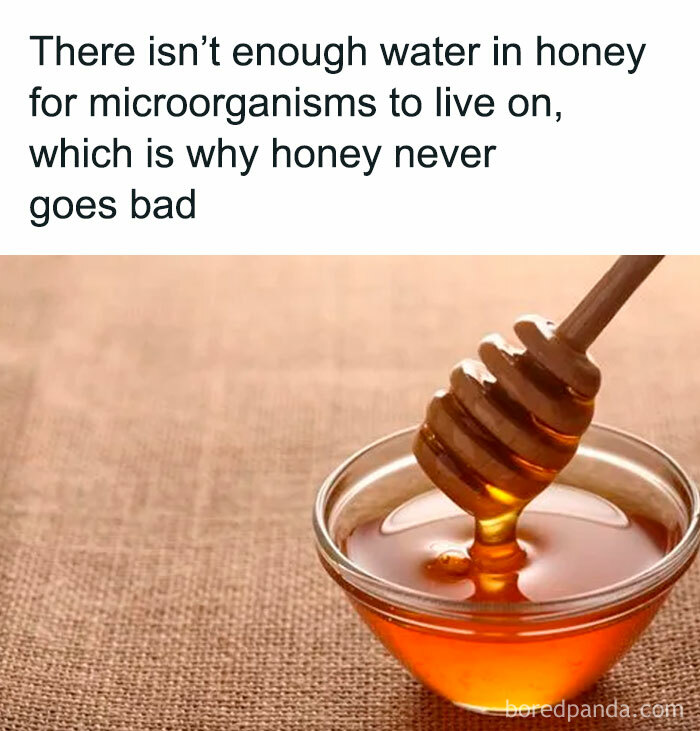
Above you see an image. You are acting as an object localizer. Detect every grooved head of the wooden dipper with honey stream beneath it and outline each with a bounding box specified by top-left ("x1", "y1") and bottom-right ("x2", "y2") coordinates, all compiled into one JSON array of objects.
[{"x1": 413, "y1": 317, "x2": 600, "y2": 601}]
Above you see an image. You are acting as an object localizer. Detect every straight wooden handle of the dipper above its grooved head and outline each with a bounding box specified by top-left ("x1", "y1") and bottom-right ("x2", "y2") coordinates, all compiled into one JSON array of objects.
[{"x1": 557, "y1": 255, "x2": 663, "y2": 352}]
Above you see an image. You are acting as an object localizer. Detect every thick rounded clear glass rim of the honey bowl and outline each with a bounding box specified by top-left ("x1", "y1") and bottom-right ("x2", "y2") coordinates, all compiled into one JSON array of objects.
[{"x1": 312, "y1": 422, "x2": 700, "y2": 623}]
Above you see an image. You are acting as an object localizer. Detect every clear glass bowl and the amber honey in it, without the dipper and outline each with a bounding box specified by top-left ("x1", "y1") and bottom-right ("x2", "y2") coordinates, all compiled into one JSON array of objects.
[{"x1": 313, "y1": 424, "x2": 700, "y2": 713}]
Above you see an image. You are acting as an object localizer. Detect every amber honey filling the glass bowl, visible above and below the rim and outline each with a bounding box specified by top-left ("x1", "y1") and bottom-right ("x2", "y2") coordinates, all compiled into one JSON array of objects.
[{"x1": 344, "y1": 484, "x2": 675, "y2": 711}]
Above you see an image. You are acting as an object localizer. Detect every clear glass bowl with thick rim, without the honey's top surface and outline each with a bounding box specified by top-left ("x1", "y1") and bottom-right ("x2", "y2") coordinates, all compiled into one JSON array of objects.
[{"x1": 313, "y1": 424, "x2": 700, "y2": 713}]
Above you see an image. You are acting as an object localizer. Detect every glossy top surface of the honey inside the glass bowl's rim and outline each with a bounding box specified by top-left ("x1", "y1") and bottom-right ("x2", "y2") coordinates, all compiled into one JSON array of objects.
[{"x1": 344, "y1": 483, "x2": 675, "y2": 602}]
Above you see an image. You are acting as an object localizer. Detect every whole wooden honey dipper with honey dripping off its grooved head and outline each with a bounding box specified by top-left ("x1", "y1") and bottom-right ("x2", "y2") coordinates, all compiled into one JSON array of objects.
[{"x1": 413, "y1": 256, "x2": 663, "y2": 570}]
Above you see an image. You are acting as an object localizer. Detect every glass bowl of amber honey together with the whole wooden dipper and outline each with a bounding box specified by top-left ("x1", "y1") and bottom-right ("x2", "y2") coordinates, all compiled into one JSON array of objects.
[{"x1": 314, "y1": 256, "x2": 700, "y2": 713}]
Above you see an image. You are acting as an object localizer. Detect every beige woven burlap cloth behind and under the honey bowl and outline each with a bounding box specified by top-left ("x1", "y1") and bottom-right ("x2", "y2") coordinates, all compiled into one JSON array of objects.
[{"x1": 0, "y1": 258, "x2": 700, "y2": 731}]
